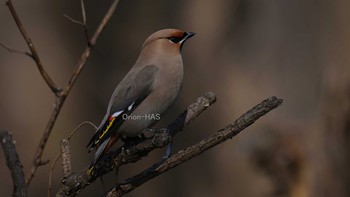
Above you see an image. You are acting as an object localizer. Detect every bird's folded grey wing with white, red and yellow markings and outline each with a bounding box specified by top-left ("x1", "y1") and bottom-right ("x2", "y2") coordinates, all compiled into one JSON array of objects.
[{"x1": 87, "y1": 65, "x2": 158, "y2": 152}]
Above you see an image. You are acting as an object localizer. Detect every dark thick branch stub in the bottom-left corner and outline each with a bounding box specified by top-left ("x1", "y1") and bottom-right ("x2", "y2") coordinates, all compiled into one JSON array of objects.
[{"x1": 0, "y1": 131, "x2": 27, "y2": 197}]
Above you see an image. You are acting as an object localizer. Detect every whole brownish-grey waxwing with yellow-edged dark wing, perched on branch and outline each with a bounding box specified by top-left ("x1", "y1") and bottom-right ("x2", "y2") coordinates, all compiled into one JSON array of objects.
[{"x1": 87, "y1": 29, "x2": 195, "y2": 174}]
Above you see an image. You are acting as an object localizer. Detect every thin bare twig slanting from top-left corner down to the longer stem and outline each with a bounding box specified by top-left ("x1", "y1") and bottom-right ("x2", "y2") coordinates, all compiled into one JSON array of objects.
[{"x1": 6, "y1": 0, "x2": 60, "y2": 95}]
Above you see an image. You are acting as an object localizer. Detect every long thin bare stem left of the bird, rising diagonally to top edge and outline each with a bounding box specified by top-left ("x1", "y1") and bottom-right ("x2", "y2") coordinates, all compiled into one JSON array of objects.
[{"x1": 25, "y1": 0, "x2": 119, "y2": 185}]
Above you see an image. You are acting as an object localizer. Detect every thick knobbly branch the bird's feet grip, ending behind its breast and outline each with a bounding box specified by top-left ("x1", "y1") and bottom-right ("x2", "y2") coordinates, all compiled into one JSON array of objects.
[{"x1": 56, "y1": 92, "x2": 216, "y2": 197}]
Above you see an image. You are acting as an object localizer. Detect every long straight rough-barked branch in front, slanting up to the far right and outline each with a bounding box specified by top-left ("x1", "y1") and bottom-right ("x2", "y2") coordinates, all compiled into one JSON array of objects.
[{"x1": 106, "y1": 97, "x2": 283, "y2": 197}]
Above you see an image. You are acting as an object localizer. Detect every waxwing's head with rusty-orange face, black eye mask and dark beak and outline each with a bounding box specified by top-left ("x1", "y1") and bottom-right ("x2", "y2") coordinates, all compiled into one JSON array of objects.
[{"x1": 143, "y1": 29, "x2": 195, "y2": 50}]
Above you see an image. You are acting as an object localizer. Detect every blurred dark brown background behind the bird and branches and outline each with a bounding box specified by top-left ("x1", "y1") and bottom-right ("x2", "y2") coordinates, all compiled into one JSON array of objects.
[{"x1": 0, "y1": 0, "x2": 350, "y2": 197}]
